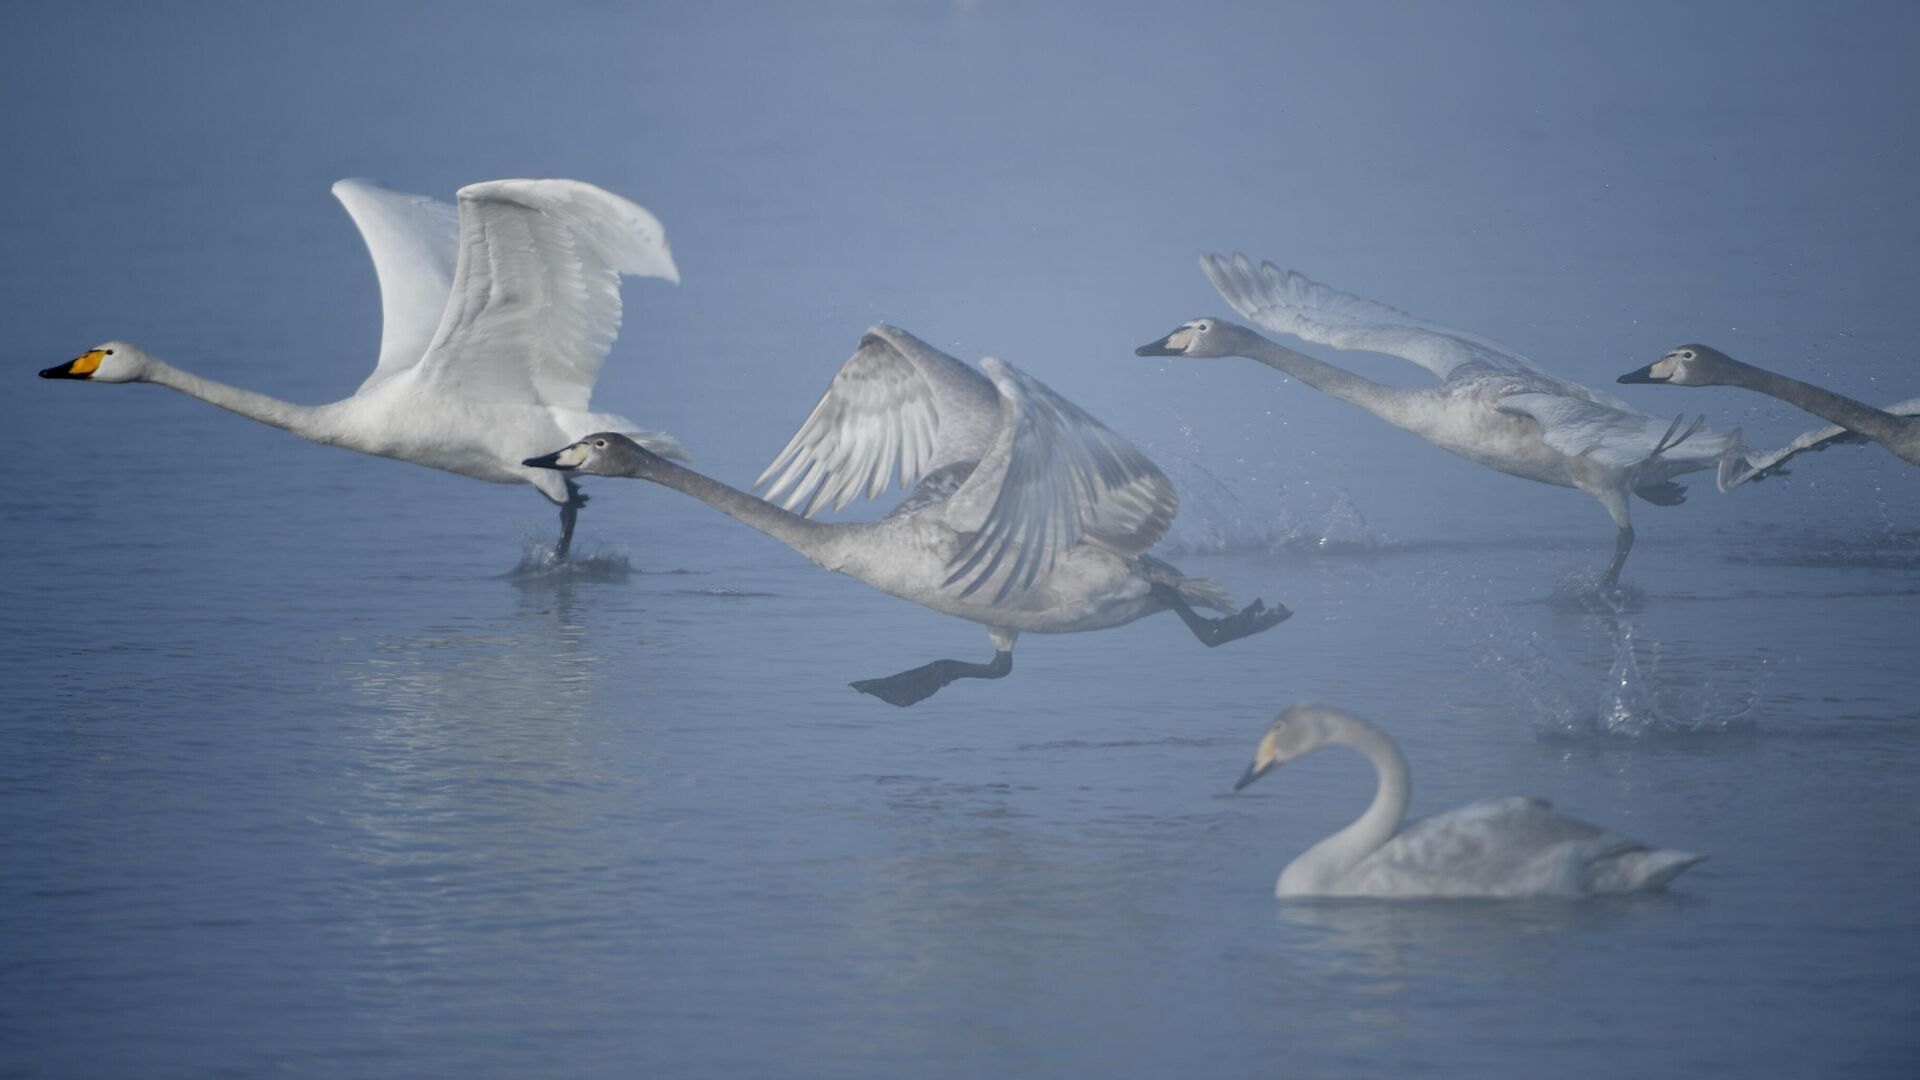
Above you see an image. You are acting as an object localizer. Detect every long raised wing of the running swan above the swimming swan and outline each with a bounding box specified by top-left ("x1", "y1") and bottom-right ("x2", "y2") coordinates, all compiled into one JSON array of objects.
[{"x1": 1198, "y1": 252, "x2": 1540, "y2": 379}]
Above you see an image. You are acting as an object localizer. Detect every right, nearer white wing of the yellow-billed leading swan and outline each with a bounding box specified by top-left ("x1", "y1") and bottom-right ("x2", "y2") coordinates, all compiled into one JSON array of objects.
[{"x1": 420, "y1": 181, "x2": 680, "y2": 409}]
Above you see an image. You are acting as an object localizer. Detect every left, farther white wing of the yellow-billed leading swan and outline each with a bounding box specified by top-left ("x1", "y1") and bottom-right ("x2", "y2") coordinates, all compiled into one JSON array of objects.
[{"x1": 334, "y1": 179, "x2": 461, "y2": 392}]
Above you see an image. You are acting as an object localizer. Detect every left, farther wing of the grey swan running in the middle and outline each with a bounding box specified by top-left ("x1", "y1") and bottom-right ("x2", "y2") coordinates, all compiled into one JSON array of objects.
[{"x1": 753, "y1": 325, "x2": 1000, "y2": 517}]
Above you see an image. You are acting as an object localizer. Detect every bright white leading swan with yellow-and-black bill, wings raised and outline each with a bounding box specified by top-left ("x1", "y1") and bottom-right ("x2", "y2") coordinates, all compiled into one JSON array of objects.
[{"x1": 40, "y1": 181, "x2": 685, "y2": 557}]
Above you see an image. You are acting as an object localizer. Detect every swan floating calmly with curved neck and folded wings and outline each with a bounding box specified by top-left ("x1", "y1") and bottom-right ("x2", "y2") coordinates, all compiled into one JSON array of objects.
[{"x1": 1235, "y1": 705, "x2": 1705, "y2": 899}]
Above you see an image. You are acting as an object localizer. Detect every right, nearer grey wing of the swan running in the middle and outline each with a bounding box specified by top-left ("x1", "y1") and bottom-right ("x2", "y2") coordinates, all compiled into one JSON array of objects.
[{"x1": 945, "y1": 357, "x2": 1181, "y2": 601}]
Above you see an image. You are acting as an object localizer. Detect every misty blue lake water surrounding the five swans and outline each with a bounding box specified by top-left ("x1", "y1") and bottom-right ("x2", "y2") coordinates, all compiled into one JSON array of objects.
[{"x1": 0, "y1": 4, "x2": 1920, "y2": 1078}]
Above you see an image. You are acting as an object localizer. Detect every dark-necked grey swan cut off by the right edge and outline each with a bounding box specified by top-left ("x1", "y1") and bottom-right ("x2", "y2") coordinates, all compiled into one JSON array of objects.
[{"x1": 1620, "y1": 344, "x2": 1920, "y2": 492}]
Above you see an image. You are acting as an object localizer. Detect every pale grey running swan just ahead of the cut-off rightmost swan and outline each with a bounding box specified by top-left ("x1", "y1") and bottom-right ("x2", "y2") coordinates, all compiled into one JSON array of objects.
[{"x1": 1135, "y1": 254, "x2": 1728, "y2": 588}]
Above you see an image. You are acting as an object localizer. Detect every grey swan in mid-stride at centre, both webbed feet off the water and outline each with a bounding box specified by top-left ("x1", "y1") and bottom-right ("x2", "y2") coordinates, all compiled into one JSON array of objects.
[{"x1": 526, "y1": 325, "x2": 1290, "y2": 705}]
